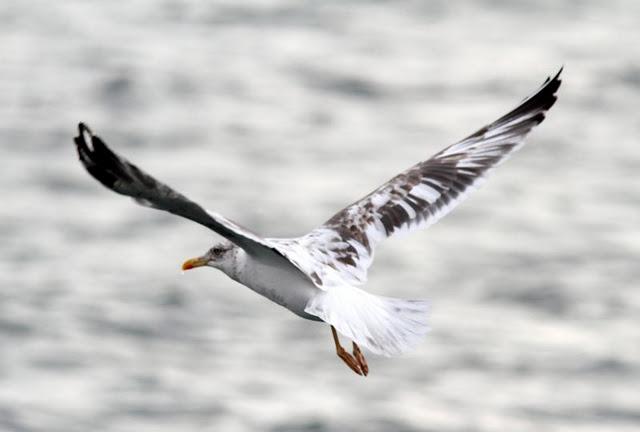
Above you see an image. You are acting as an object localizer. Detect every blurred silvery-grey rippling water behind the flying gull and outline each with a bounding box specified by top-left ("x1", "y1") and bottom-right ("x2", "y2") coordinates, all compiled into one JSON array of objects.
[{"x1": 0, "y1": 0, "x2": 640, "y2": 432}]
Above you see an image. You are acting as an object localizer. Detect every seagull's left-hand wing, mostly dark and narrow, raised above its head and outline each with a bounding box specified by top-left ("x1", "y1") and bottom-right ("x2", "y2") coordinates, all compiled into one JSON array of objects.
[{"x1": 74, "y1": 123, "x2": 279, "y2": 254}]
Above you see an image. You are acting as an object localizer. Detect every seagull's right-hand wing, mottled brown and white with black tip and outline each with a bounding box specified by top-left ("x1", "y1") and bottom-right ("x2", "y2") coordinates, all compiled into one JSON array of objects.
[{"x1": 288, "y1": 69, "x2": 562, "y2": 285}]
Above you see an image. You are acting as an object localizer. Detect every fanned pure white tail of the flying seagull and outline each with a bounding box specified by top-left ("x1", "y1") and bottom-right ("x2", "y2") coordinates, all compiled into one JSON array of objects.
[{"x1": 305, "y1": 285, "x2": 429, "y2": 357}]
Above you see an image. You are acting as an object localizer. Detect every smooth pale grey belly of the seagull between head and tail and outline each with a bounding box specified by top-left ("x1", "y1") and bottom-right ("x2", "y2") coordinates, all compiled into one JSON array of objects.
[{"x1": 238, "y1": 253, "x2": 321, "y2": 321}]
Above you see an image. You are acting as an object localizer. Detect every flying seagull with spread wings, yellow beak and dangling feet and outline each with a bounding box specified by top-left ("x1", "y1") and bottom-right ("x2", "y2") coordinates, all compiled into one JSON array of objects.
[{"x1": 74, "y1": 68, "x2": 562, "y2": 376}]
